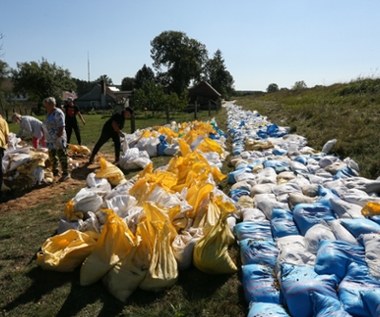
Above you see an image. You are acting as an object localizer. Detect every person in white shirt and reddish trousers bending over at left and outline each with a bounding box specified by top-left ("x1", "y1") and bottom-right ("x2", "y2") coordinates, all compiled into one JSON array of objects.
[{"x1": 12, "y1": 112, "x2": 46, "y2": 149}]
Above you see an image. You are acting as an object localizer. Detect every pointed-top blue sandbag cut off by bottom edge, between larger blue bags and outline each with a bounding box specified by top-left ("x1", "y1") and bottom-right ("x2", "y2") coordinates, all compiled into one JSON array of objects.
[{"x1": 311, "y1": 292, "x2": 351, "y2": 317}]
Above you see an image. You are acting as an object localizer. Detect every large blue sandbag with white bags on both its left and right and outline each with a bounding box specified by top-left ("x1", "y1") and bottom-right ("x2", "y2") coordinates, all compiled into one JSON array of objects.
[{"x1": 314, "y1": 240, "x2": 366, "y2": 279}]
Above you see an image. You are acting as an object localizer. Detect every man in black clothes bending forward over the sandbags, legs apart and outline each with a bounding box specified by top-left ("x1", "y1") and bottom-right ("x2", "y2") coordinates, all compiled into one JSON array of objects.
[{"x1": 88, "y1": 107, "x2": 133, "y2": 164}]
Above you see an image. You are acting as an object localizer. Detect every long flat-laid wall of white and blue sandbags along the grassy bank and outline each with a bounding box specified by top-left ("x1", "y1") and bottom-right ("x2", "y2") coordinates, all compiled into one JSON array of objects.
[{"x1": 226, "y1": 104, "x2": 380, "y2": 317}]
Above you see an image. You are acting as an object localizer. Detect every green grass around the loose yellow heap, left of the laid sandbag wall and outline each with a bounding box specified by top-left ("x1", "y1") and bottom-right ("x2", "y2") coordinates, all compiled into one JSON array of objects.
[{"x1": 0, "y1": 107, "x2": 247, "y2": 317}]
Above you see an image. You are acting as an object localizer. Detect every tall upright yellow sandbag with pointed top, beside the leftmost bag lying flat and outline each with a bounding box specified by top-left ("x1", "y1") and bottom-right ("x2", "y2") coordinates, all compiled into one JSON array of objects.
[{"x1": 80, "y1": 209, "x2": 136, "y2": 285}]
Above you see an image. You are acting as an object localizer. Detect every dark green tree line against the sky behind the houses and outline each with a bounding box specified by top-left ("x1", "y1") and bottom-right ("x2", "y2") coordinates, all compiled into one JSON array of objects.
[{"x1": 0, "y1": 31, "x2": 234, "y2": 114}]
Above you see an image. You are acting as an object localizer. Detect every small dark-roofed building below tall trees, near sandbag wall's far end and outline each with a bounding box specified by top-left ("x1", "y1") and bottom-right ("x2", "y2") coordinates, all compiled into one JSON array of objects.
[{"x1": 189, "y1": 81, "x2": 222, "y2": 110}]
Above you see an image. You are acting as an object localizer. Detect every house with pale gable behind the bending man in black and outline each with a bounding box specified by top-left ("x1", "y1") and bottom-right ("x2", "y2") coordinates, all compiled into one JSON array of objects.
[{"x1": 75, "y1": 84, "x2": 132, "y2": 111}]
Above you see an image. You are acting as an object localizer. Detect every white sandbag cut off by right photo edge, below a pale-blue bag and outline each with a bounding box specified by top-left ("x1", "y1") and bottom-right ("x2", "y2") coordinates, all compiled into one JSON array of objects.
[{"x1": 361, "y1": 233, "x2": 380, "y2": 279}]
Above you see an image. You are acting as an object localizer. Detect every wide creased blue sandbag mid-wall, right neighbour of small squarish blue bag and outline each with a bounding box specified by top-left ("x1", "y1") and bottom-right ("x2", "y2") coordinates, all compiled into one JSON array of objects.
[{"x1": 293, "y1": 203, "x2": 335, "y2": 236}]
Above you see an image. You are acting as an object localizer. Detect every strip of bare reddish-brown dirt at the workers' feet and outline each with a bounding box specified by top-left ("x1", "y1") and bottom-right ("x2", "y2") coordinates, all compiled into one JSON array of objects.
[{"x1": 0, "y1": 154, "x2": 112, "y2": 213}]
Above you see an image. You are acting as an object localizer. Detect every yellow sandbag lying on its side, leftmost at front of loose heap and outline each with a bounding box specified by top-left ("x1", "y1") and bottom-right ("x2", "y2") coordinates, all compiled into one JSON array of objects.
[{"x1": 37, "y1": 229, "x2": 99, "y2": 272}]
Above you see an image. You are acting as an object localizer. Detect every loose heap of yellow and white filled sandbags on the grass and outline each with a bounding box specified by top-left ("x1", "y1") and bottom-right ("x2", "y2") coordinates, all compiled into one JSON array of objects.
[{"x1": 37, "y1": 121, "x2": 237, "y2": 301}]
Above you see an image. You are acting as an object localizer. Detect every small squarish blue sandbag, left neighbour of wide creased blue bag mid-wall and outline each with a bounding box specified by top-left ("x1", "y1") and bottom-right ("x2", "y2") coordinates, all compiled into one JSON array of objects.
[{"x1": 270, "y1": 208, "x2": 300, "y2": 239}]
